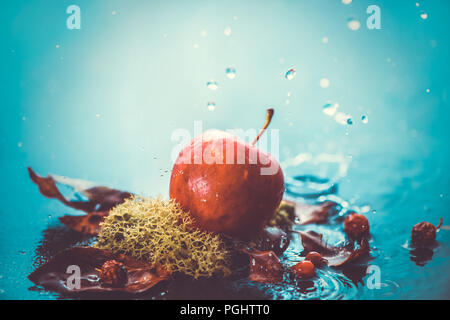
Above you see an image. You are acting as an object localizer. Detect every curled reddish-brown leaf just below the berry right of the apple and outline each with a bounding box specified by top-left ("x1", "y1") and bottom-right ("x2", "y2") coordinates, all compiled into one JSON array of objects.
[{"x1": 298, "y1": 231, "x2": 370, "y2": 267}]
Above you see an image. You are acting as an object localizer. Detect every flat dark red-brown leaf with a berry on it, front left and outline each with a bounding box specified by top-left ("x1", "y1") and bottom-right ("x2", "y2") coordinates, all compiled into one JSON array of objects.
[{"x1": 28, "y1": 247, "x2": 171, "y2": 294}]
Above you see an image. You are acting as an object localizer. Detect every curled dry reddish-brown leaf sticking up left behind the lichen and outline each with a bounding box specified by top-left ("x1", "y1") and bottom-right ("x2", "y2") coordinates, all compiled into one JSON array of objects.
[{"x1": 28, "y1": 168, "x2": 132, "y2": 235}]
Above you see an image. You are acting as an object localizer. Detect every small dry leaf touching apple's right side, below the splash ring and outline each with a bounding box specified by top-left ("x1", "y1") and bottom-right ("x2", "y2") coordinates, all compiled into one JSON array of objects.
[{"x1": 283, "y1": 200, "x2": 339, "y2": 225}]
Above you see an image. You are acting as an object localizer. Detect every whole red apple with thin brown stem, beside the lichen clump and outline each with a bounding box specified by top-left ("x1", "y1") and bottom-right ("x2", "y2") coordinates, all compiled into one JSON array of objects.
[{"x1": 170, "y1": 109, "x2": 284, "y2": 239}]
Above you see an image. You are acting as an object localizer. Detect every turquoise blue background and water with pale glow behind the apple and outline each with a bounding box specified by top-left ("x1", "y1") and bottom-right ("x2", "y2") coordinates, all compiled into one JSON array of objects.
[{"x1": 0, "y1": 0, "x2": 450, "y2": 299}]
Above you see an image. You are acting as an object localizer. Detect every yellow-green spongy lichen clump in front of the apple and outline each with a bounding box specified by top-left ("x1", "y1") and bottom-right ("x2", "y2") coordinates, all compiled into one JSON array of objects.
[{"x1": 95, "y1": 197, "x2": 231, "y2": 278}]
